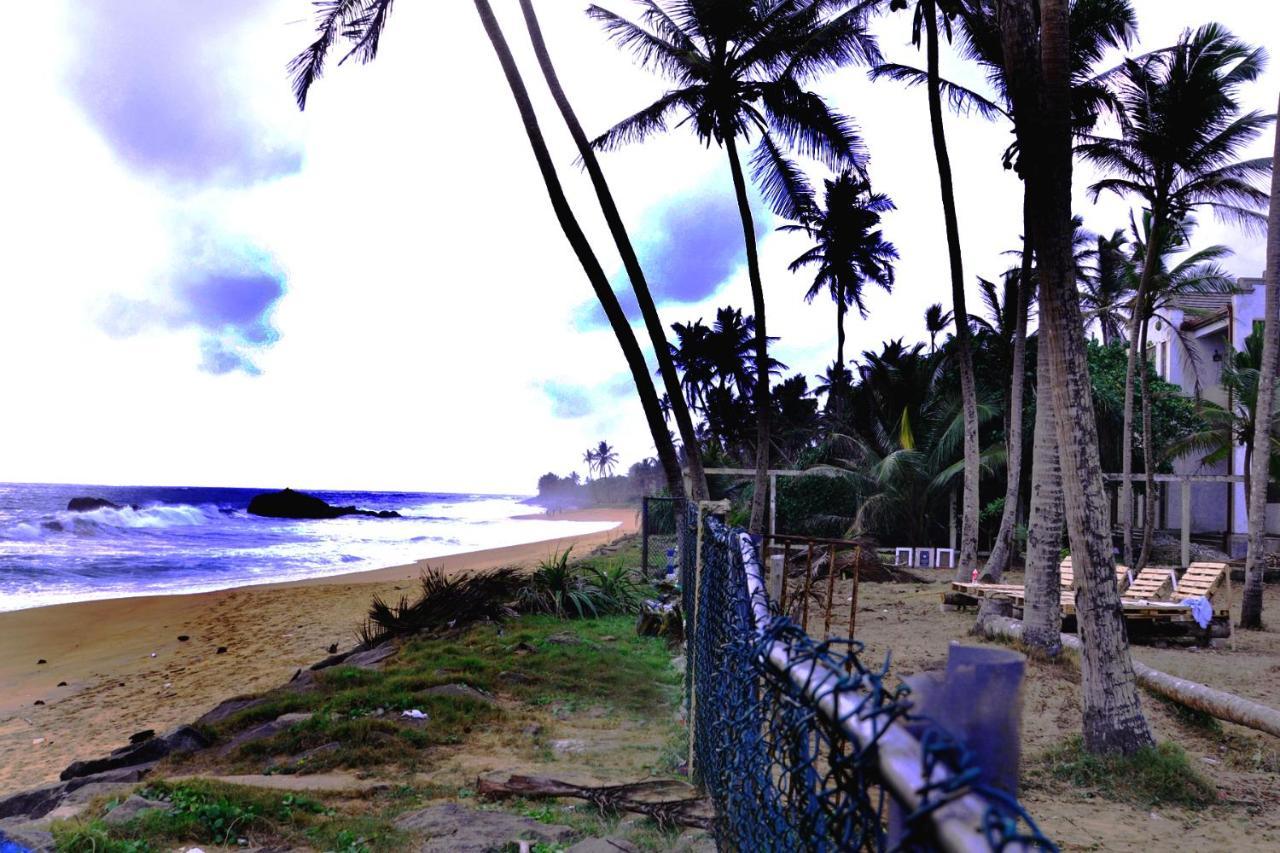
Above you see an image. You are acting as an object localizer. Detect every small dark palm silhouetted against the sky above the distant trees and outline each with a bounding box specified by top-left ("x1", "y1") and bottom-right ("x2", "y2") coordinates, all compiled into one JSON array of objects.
[{"x1": 782, "y1": 170, "x2": 897, "y2": 365}]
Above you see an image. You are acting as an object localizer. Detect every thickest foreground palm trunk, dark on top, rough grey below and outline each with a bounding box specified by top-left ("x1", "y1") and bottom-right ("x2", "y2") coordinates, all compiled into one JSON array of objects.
[{"x1": 1001, "y1": 0, "x2": 1153, "y2": 754}]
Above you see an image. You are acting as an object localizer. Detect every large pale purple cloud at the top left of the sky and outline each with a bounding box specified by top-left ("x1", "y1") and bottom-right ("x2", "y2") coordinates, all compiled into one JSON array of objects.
[{"x1": 69, "y1": 0, "x2": 301, "y2": 184}]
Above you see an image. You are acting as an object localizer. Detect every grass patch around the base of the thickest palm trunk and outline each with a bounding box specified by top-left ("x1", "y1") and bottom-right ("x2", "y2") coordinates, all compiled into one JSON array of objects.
[{"x1": 1030, "y1": 735, "x2": 1217, "y2": 807}]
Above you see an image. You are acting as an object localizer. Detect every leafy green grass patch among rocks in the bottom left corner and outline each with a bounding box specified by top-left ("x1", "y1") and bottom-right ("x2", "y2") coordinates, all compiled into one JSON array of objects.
[{"x1": 51, "y1": 780, "x2": 404, "y2": 853}]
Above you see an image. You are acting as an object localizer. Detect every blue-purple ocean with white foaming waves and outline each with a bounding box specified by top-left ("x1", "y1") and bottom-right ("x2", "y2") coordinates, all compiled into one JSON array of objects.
[{"x1": 0, "y1": 483, "x2": 614, "y2": 611}]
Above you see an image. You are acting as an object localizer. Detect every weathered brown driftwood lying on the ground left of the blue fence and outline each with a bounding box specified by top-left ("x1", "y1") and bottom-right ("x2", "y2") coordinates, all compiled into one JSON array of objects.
[{"x1": 476, "y1": 775, "x2": 713, "y2": 829}]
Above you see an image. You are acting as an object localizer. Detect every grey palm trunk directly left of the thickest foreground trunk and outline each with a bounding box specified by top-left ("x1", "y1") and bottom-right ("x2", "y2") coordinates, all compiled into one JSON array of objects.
[{"x1": 1023, "y1": 336, "x2": 1062, "y2": 657}]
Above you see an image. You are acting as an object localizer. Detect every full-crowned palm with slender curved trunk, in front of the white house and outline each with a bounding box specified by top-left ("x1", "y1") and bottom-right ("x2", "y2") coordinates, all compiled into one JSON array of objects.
[{"x1": 1079, "y1": 24, "x2": 1271, "y2": 565}]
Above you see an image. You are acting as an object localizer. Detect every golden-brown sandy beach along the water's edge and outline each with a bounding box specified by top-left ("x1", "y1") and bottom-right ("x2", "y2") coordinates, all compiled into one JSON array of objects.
[{"x1": 0, "y1": 508, "x2": 637, "y2": 794}]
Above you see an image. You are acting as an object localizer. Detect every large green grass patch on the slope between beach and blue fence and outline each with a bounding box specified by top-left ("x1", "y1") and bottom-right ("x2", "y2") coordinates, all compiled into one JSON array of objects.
[{"x1": 179, "y1": 615, "x2": 681, "y2": 772}]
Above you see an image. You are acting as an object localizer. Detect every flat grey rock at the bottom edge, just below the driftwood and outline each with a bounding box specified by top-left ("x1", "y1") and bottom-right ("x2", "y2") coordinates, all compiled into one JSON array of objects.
[{"x1": 396, "y1": 803, "x2": 573, "y2": 853}]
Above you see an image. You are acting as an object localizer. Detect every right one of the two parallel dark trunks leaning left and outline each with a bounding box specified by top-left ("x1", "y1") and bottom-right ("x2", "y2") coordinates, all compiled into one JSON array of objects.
[{"x1": 520, "y1": 0, "x2": 709, "y2": 501}]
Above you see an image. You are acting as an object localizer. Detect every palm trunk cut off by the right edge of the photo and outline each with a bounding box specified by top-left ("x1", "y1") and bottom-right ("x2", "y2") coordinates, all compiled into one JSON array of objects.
[{"x1": 1240, "y1": 99, "x2": 1280, "y2": 629}]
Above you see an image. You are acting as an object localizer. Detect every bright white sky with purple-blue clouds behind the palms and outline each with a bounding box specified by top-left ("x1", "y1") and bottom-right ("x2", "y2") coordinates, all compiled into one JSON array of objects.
[{"x1": 0, "y1": 0, "x2": 1280, "y2": 493}]
